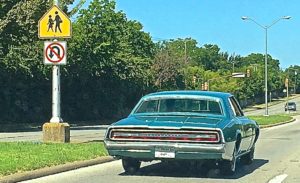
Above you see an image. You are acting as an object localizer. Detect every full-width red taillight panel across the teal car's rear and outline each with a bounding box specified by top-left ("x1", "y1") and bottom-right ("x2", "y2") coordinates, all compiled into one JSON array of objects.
[{"x1": 110, "y1": 130, "x2": 220, "y2": 143}]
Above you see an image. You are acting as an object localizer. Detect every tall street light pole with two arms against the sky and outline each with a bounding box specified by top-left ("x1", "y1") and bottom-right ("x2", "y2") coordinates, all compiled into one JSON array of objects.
[{"x1": 242, "y1": 16, "x2": 291, "y2": 116}]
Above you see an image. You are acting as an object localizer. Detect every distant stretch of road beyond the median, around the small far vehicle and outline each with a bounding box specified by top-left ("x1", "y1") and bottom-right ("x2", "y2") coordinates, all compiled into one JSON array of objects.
[{"x1": 245, "y1": 96, "x2": 300, "y2": 115}]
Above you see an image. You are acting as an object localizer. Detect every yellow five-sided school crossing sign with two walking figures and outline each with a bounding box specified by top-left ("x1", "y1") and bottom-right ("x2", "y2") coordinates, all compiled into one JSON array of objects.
[{"x1": 39, "y1": 5, "x2": 72, "y2": 39}]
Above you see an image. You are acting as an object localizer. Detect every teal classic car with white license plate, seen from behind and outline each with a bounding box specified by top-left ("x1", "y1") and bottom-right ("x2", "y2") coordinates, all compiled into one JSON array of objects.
[{"x1": 104, "y1": 91, "x2": 259, "y2": 174}]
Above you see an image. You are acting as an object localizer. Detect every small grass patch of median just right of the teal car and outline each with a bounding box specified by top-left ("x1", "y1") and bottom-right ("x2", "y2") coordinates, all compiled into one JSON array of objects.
[{"x1": 248, "y1": 114, "x2": 293, "y2": 125}]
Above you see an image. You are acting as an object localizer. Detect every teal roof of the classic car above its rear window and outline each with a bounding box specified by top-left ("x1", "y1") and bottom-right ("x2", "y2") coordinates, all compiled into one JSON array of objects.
[{"x1": 144, "y1": 90, "x2": 232, "y2": 99}]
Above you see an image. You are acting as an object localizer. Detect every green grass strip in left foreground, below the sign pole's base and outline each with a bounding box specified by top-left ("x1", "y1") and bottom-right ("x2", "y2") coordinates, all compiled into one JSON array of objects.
[{"x1": 0, "y1": 142, "x2": 107, "y2": 177}]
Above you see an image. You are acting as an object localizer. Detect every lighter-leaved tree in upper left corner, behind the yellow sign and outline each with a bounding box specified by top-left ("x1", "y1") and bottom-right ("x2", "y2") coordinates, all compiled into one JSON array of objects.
[{"x1": 0, "y1": 0, "x2": 73, "y2": 76}]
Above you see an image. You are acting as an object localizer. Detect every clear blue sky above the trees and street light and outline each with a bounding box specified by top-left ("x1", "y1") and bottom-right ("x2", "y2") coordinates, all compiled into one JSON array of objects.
[{"x1": 71, "y1": 0, "x2": 300, "y2": 69}]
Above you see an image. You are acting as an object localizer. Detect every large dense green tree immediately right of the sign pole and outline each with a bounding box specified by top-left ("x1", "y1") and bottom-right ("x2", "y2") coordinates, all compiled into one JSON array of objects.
[{"x1": 63, "y1": 0, "x2": 154, "y2": 119}]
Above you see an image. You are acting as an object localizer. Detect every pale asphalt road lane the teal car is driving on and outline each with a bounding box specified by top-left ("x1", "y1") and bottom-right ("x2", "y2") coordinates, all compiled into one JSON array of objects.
[{"x1": 19, "y1": 116, "x2": 300, "y2": 183}]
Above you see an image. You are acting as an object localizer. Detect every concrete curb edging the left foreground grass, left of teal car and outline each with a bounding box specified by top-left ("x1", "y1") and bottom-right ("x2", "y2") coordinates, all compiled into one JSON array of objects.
[{"x1": 0, "y1": 156, "x2": 114, "y2": 183}]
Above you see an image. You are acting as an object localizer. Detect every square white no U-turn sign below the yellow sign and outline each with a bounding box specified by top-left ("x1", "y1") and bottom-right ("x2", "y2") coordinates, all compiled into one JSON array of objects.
[{"x1": 44, "y1": 41, "x2": 67, "y2": 65}]
